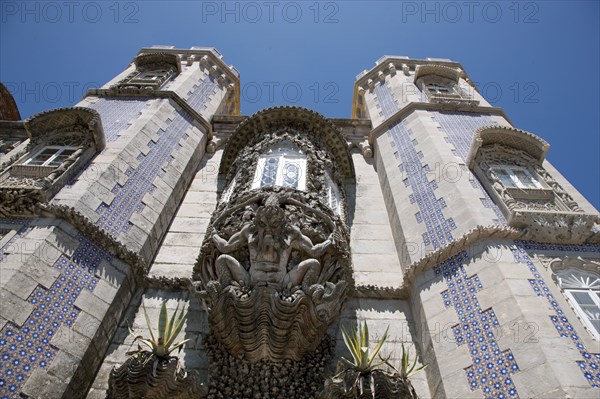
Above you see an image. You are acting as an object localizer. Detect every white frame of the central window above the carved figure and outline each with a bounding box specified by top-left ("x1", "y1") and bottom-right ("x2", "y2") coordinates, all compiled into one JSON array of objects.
[{"x1": 252, "y1": 144, "x2": 306, "y2": 191}]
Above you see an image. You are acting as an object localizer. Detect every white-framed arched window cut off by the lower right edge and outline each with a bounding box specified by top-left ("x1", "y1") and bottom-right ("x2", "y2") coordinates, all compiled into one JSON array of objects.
[{"x1": 556, "y1": 269, "x2": 600, "y2": 340}]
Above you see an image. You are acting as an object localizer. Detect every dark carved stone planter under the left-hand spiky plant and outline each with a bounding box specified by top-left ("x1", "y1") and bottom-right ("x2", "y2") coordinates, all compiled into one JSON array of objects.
[{"x1": 106, "y1": 354, "x2": 207, "y2": 399}]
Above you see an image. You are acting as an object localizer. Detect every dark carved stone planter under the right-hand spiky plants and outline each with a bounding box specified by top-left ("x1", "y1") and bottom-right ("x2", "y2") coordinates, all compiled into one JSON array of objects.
[{"x1": 319, "y1": 370, "x2": 417, "y2": 399}]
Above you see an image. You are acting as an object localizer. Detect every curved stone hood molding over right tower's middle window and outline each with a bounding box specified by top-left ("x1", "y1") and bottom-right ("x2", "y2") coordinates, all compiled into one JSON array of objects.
[{"x1": 466, "y1": 125, "x2": 550, "y2": 169}]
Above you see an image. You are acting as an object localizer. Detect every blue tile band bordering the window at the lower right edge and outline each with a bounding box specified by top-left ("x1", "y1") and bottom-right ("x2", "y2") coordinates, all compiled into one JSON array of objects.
[{"x1": 512, "y1": 240, "x2": 600, "y2": 388}]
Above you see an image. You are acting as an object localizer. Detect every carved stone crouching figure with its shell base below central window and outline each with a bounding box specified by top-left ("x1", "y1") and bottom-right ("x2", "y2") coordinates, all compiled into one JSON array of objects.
[{"x1": 193, "y1": 189, "x2": 350, "y2": 361}]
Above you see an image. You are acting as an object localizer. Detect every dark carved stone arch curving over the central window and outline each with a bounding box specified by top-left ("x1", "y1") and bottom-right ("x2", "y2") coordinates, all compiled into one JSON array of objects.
[{"x1": 219, "y1": 106, "x2": 354, "y2": 178}]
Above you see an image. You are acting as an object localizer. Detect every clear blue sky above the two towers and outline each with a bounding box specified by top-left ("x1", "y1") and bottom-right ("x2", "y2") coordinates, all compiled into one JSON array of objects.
[{"x1": 0, "y1": 0, "x2": 600, "y2": 208}]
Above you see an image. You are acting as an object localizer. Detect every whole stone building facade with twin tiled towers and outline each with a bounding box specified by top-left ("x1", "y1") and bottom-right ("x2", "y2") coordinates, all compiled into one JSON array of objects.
[{"x1": 0, "y1": 47, "x2": 600, "y2": 398}]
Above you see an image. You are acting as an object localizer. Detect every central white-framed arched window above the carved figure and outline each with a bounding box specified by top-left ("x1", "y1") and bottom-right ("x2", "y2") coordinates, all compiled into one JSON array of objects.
[{"x1": 252, "y1": 141, "x2": 306, "y2": 190}]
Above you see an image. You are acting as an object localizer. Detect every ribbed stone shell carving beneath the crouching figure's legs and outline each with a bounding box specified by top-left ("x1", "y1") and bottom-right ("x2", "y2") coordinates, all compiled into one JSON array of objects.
[{"x1": 202, "y1": 281, "x2": 345, "y2": 362}]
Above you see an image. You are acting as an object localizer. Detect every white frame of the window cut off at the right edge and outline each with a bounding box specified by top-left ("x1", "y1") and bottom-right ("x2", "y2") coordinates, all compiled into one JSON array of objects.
[{"x1": 557, "y1": 269, "x2": 600, "y2": 340}]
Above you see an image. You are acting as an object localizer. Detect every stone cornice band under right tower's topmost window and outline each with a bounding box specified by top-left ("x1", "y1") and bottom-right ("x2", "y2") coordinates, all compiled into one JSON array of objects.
[{"x1": 369, "y1": 102, "x2": 512, "y2": 145}]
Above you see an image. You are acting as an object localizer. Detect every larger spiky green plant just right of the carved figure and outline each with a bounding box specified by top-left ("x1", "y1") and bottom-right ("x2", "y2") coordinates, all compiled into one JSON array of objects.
[{"x1": 341, "y1": 321, "x2": 389, "y2": 373}]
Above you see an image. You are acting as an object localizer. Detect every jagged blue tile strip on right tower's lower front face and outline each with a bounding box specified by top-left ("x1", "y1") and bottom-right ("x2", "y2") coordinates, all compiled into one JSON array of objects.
[{"x1": 434, "y1": 251, "x2": 519, "y2": 398}]
